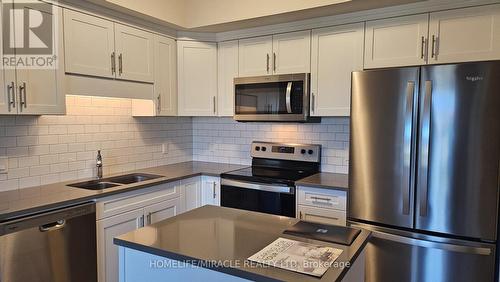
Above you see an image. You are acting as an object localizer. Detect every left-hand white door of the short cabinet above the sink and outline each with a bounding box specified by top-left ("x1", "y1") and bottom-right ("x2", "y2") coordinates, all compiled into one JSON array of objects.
[{"x1": 64, "y1": 9, "x2": 116, "y2": 78}]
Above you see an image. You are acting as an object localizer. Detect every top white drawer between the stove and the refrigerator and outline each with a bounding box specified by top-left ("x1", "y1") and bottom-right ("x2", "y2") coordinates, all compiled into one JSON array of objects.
[{"x1": 298, "y1": 187, "x2": 347, "y2": 211}]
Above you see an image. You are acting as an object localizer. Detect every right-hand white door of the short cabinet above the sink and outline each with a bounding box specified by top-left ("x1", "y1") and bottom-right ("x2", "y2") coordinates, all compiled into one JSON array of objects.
[{"x1": 115, "y1": 24, "x2": 154, "y2": 83}]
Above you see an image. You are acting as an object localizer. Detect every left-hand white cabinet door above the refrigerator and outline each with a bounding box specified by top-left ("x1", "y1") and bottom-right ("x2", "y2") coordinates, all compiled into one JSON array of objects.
[{"x1": 365, "y1": 14, "x2": 429, "y2": 68}]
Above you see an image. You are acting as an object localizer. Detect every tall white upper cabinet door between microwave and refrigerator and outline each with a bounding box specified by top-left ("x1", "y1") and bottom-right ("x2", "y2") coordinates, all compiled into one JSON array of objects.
[{"x1": 311, "y1": 23, "x2": 364, "y2": 116}]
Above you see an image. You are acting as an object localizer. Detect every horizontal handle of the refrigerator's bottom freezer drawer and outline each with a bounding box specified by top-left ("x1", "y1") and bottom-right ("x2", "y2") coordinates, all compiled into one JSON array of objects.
[{"x1": 372, "y1": 230, "x2": 493, "y2": 256}]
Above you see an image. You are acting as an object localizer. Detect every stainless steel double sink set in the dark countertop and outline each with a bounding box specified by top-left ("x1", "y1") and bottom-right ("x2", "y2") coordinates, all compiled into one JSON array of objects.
[{"x1": 68, "y1": 173, "x2": 163, "y2": 190}]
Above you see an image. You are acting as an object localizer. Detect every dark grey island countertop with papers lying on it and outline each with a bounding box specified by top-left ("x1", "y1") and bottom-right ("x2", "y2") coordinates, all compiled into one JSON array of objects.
[{"x1": 114, "y1": 206, "x2": 371, "y2": 282}]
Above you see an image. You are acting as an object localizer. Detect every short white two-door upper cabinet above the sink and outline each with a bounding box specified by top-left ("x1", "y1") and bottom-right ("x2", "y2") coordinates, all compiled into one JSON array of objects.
[{"x1": 64, "y1": 9, "x2": 154, "y2": 83}]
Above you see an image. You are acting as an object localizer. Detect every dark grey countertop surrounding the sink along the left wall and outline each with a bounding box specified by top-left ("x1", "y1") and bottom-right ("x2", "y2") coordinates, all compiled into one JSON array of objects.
[{"x1": 0, "y1": 162, "x2": 246, "y2": 222}]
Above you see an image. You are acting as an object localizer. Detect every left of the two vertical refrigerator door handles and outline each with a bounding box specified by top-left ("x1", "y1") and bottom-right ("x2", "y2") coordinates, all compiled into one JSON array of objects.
[{"x1": 401, "y1": 81, "x2": 415, "y2": 214}]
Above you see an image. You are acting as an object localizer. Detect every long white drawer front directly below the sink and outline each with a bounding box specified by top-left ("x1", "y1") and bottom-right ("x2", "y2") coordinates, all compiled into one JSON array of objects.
[{"x1": 96, "y1": 181, "x2": 180, "y2": 219}]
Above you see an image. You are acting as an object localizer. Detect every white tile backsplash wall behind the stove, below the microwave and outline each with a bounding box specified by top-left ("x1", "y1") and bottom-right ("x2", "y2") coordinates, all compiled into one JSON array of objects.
[{"x1": 193, "y1": 117, "x2": 349, "y2": 173}]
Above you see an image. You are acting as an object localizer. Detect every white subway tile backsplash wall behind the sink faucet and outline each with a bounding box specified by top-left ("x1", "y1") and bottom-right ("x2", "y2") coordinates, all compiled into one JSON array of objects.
[{"x1": 0, "y1": 96, "x2": 192, "y2": 191}]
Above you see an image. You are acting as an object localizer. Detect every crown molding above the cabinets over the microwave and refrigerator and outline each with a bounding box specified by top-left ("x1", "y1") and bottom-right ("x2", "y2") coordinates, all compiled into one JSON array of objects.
[{"x1": 216, "y1": 0, "x2": 500, "y2": 42}]
